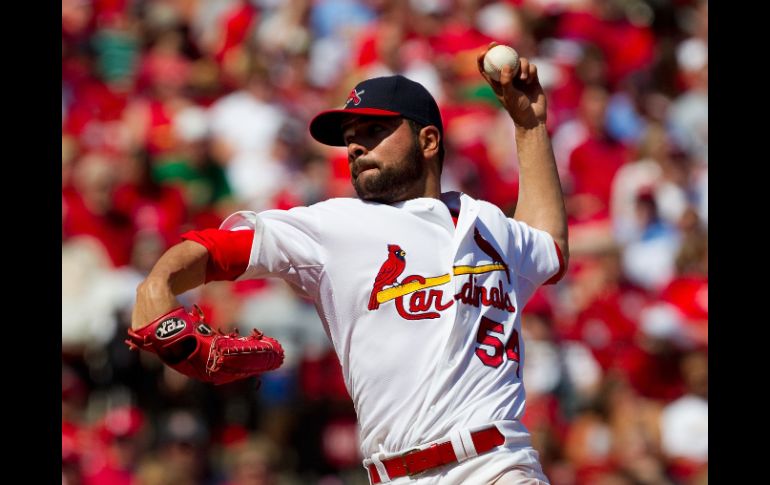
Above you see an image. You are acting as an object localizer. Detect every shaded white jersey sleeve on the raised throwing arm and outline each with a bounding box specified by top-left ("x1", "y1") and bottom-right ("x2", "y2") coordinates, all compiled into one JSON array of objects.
[{"x1": 508, "y1": 219, "x2": 567, "y2": 288}]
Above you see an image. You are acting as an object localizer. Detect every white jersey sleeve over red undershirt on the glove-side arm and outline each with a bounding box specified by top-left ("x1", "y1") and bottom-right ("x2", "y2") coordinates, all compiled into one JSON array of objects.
[{"x1": 220, "y1": 207, "x2": 325, "y2": 294}]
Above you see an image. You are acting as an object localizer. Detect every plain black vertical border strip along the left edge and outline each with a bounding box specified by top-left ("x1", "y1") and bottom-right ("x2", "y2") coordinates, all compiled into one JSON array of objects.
[{"x1": 5, "y1": 2, "x2": 61, "y2": 483}]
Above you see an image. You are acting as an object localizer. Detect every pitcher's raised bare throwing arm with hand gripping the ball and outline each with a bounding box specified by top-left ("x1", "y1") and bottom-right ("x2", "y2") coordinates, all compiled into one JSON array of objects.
[{"x1": 477, "y1": 43, "x2": 569, "y2": 268}]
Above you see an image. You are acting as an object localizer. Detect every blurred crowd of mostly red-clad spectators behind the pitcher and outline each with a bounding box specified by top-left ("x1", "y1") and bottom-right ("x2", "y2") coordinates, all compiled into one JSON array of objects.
[{"x1": 62, "y1": 0, "x2": 708, "y2": 485}]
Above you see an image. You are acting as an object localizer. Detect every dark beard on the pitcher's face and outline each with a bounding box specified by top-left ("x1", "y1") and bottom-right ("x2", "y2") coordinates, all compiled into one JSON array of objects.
[{"x1": 351, "y1": 139, "x2": 425, "y2": 204}]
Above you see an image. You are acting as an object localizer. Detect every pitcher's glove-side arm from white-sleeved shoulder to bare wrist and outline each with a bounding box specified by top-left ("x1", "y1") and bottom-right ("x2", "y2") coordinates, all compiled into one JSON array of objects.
[{"x1": 131, "y1": 208, "x2": 322, "y2": 330}]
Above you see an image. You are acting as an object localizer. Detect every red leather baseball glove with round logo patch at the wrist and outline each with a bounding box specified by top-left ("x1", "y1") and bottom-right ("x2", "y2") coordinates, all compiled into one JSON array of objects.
[{"x1": 126, "y1": 305, "x2": 283, "y2": 385}]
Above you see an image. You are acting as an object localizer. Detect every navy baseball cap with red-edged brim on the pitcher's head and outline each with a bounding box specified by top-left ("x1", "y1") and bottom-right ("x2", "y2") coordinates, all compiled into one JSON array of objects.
[{"x1": 310, "y1": 74, "x2": 444, "y2": 146}]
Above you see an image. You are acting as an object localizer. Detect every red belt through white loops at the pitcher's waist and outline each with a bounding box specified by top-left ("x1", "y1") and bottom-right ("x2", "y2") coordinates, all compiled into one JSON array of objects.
[{"x1": 368, "y1": 426, "x2": 505, "y2": 484}]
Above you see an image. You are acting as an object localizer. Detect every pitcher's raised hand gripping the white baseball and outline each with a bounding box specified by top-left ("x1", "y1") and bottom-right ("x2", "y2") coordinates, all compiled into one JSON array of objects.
[{"x1": 476, "y1": 42, "x2": 546, "y2": 128}]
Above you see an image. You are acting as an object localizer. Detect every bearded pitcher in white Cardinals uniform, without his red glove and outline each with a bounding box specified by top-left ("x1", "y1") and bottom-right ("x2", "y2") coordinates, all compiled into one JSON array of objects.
[{"x1": 132, "y1": 45, "x2": 568, "y2": 484}]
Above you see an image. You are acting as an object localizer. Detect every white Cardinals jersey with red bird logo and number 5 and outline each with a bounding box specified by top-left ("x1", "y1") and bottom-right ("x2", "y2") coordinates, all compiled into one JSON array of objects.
[{"x1": 221, "y1": 192, "x2": 562, "y2": 456}]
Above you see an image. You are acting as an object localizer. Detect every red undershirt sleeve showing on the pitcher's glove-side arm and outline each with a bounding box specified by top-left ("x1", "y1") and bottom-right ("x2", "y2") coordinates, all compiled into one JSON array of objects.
[{"x1": 181, "y1": 229, "x2": 254, "y2": 283}]
